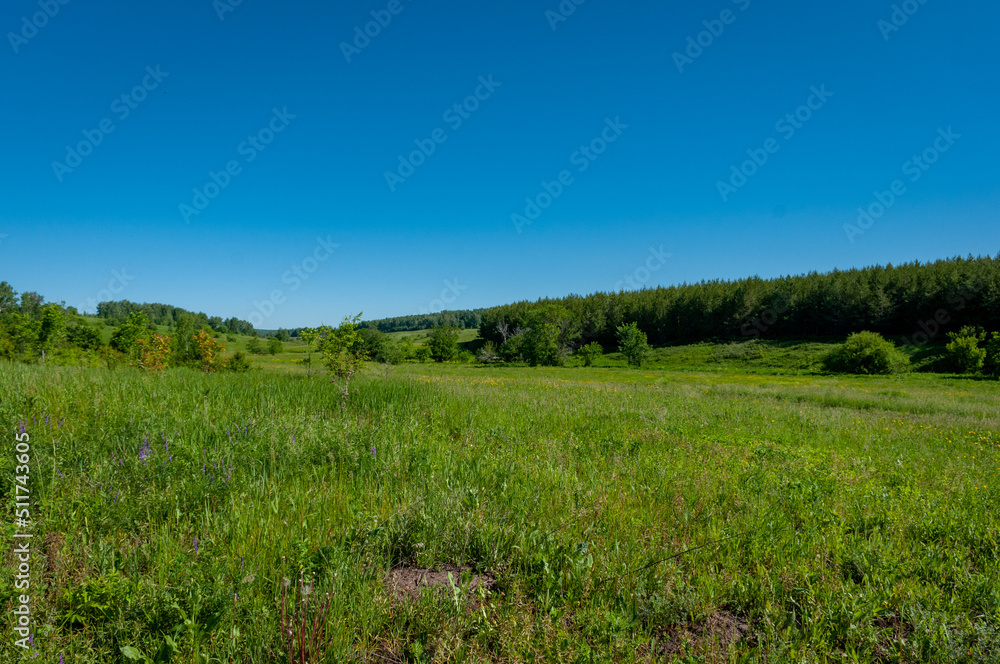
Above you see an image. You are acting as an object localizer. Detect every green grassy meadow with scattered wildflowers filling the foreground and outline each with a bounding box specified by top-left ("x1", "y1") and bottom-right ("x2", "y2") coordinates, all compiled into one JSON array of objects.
[{"x1": 0, "y1": 345, "x2": 1000, "y2": 663}]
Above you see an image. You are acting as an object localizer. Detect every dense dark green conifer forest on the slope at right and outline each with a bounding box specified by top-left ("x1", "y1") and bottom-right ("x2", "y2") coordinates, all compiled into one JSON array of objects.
[{"x1": 479, "y1": 255, "x2": 1000, "y2": 352}]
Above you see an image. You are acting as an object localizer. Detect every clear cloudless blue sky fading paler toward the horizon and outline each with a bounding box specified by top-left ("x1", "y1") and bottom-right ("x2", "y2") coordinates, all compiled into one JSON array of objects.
[{"x1": 0, "y1": 0, "x2": 1000, "y2": 328}]
